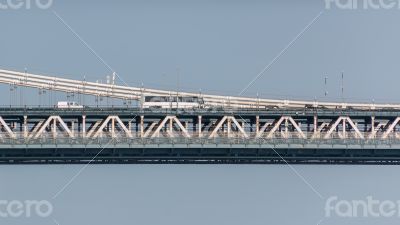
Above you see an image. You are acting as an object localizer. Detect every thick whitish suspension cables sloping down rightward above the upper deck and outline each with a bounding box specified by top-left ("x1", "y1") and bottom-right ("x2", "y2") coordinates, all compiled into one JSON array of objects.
[{"x1": 0, "y1": 70, "x2": 400, "y2": 110}]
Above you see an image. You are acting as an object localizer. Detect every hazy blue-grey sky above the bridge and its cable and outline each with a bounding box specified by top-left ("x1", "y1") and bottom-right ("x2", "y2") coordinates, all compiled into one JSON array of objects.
[{"x1": 0, "y1": 0, "x2": 400, "y2": 104}]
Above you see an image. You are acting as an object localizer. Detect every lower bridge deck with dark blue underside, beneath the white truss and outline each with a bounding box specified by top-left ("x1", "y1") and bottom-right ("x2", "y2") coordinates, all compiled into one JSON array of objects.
[{"x1": 0, "y1": 138, "x2": 400, "y2": 164}]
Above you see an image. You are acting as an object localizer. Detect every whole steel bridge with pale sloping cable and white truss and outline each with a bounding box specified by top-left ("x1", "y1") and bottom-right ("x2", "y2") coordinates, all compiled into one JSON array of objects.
[{"x1": 0, "y1": 68, "x2": 400, "y2": 164}]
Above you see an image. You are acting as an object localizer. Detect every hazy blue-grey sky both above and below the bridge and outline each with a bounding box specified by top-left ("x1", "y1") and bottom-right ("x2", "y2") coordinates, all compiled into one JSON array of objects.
[{"x1": 0, "y1": 0, "x2": 400, "y2": 225}]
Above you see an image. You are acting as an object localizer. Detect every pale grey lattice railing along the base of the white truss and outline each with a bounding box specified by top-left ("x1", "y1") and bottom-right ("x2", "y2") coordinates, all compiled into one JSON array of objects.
[{"x1": 0, "y1": 136, "x2": 400, "y2": 148}]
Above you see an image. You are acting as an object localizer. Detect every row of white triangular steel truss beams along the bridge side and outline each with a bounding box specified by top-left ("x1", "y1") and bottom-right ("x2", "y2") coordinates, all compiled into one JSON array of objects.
[{"x1": 0, "y1": 109, "x2": 400, "y2": 142}]
